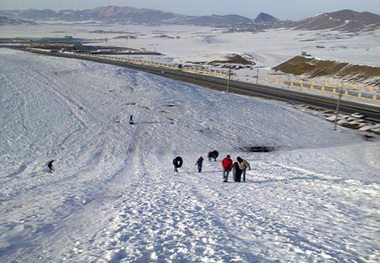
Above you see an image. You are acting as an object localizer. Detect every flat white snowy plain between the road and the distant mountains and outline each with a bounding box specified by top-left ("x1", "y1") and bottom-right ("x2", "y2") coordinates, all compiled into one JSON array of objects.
[{"x1": 1, "y1": 23, "x2": 380, "y2": 67}]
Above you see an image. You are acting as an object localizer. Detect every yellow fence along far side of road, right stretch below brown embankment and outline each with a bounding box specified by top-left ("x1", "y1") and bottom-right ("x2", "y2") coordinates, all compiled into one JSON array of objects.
[{"x1": 264, "y1": 76, "x2": 380, "y2": 102}]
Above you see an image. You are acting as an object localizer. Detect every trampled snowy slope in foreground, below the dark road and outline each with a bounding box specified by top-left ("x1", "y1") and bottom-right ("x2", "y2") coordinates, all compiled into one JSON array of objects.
[{"x1": 0, "y1": 49, "x2": 380, "y2": 262}]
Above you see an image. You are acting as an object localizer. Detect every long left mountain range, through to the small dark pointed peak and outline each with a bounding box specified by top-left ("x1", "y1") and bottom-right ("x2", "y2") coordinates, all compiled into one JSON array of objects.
[{"x1": 0, "y1": 6, "x2": 278, "y2": 28}]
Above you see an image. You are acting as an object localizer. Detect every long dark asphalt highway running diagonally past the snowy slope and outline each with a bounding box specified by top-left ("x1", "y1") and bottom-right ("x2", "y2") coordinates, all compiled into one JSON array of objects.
[{"x1": 18, "y1": 49, "x2": 380, "y2": 122}]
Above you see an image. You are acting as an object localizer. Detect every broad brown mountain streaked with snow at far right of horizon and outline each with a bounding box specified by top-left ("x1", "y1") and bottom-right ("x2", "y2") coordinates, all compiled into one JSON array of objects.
[{"x1": 289, "y1": 10, "x2": 380, "y2": 32}]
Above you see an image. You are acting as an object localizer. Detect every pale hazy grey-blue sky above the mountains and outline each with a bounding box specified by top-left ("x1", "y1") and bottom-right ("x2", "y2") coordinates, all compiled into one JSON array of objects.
[{"x1": 0, "y1": 0, "x2": 380, "y2": 20}]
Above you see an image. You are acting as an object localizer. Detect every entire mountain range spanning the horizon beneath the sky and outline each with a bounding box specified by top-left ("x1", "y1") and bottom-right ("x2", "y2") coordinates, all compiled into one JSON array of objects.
[{"x1": 0, "y1": 6, "x2": 380, "y2": 32}]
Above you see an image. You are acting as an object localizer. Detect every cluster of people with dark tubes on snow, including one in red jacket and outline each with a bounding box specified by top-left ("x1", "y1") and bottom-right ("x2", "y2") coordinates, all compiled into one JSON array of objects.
[{"x1": 173, "y1": 151, "x2": 251, "y2": 182}]
